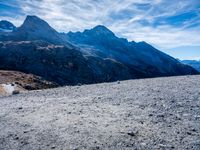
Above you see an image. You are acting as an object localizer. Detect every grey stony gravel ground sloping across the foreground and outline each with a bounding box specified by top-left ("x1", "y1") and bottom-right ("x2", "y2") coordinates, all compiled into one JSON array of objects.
[{"x1": 0, "y1": 76, "x2": 200, "y2": 150}]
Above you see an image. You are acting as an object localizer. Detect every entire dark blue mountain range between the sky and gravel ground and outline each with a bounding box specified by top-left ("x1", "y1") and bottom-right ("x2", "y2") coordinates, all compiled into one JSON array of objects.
[{"x1": 0, "y1": 16, "x2": 199, "y2": 85}]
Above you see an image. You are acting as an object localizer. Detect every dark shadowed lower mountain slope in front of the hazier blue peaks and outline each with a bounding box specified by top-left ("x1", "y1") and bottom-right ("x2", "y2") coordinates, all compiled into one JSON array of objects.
[{"x1": 0, "y1": 41, "x2": 133, "y2": 85}]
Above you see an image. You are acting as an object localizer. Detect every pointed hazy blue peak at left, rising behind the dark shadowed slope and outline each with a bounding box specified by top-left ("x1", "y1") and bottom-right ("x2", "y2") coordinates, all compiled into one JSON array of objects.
[{"x1": 0, "y1": 15, "x2": 74, "y2": 48}]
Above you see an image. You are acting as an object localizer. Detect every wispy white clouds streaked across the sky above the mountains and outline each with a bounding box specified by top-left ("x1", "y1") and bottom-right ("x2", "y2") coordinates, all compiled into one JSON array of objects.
[{"x1": 1, "y1": 0, "x2": 200, "y2": 49}]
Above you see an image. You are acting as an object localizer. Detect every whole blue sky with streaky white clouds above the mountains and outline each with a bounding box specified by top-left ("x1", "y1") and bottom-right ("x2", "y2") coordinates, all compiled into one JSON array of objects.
[{"x1": 0, "y1": 0, "x2": 200, "y2": 59}]
